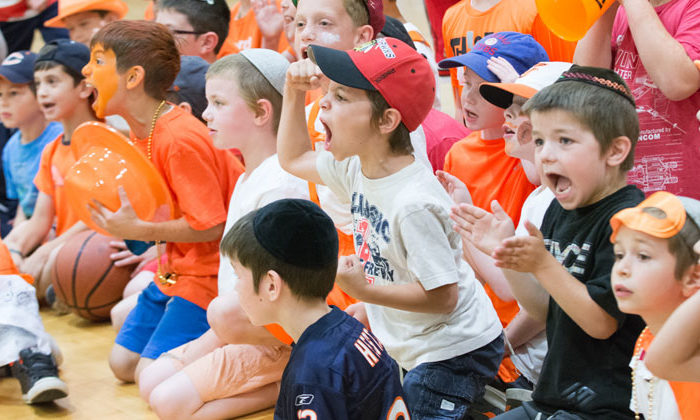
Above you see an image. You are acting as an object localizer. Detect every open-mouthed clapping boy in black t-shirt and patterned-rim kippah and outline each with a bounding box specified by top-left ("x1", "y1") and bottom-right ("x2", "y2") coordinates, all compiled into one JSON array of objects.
[{"x1": 492, "y1": 66, "x2": 643, "y2": 419}]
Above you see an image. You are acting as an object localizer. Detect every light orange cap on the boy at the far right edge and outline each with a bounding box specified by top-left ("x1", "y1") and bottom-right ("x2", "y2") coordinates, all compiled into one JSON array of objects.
[{"x1": 610, "y1": 191, "x2": 700, "y2": 245}]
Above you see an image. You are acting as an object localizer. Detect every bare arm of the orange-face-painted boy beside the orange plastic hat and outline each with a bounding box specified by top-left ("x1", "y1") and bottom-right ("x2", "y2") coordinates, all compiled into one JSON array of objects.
[{"x1": 89, "y1": 187, "x2": 224, "y2": 243}]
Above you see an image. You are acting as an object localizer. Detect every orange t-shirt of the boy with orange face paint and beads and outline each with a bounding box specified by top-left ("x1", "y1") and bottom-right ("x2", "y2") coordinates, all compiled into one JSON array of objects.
[{"x1": 131, "y1": 107, "x2": 244, "y2": 309}]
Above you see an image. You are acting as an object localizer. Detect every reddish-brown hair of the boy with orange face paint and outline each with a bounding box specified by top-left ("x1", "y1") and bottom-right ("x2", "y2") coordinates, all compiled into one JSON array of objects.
[{"x1": 90, "y1": 20, "x2": 180, "y2": 100}]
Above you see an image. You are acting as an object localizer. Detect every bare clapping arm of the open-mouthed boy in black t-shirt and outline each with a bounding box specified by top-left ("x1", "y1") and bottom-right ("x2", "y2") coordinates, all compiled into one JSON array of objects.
[{"x1": 493, "y1": 222, "x2": 618, "y2": 340}]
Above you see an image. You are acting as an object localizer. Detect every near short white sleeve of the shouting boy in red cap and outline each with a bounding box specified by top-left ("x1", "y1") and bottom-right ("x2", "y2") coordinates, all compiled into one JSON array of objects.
[{"x1": 399, "y1": 204, "x2": 459, "y2": 290}]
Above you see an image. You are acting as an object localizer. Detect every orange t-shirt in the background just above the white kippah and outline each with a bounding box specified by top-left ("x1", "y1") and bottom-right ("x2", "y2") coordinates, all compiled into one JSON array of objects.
[{"x1": 217, "y1": 0, "x2": 289, "y2": 58}]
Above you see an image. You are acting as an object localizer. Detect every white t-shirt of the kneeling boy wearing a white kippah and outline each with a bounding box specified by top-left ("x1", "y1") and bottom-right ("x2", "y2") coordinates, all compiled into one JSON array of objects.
[{"x1": 219, "y1": 154, "x2": 309, "y2": 294}]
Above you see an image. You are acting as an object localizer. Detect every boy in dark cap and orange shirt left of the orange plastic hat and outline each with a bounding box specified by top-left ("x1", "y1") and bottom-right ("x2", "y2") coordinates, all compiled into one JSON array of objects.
[{"x1": 5, "y1": 40, "x2": 95, "y2": 299}]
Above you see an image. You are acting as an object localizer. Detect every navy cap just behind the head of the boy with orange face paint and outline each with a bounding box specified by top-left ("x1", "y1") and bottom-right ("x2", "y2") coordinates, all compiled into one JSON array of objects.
[{"x1": 168, "y1": 55, "x2": 209, "y2": 120}]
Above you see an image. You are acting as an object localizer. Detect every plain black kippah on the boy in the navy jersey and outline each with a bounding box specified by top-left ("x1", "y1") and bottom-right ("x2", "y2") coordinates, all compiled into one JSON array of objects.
[{"x1": 253, "y1": 199, "x2": 338, "y2": 268}]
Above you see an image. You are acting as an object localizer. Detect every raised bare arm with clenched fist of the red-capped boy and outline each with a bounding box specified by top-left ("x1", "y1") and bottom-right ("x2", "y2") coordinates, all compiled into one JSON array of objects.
[{"x1": 277, "y1": 59, "x2": 323, "y2": 184}]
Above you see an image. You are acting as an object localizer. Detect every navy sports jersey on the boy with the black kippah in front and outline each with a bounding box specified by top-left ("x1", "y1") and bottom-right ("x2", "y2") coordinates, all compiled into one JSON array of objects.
[{"x1": 275, "y1": 307, "x2": 410, "y2": 420}]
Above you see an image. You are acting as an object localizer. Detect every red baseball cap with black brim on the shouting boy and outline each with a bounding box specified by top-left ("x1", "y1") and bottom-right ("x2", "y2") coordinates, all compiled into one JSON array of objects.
[{"x1": 309, "y1": 38, "x2": 435, "y2": 131}]
